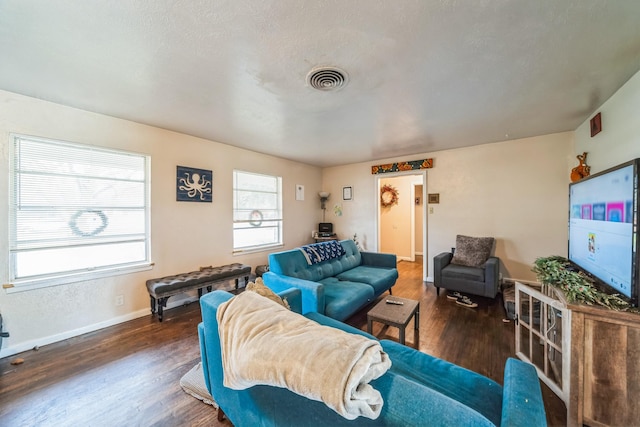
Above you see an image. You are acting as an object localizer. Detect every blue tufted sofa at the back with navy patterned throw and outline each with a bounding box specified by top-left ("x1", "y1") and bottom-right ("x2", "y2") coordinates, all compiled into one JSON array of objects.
[{"x1": 262, "y1": 240, "x2": 398, "y2": 320}]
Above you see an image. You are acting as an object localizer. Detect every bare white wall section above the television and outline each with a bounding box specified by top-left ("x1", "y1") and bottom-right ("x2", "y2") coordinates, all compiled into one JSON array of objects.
[{"x1": 573, "y1": 72, "x2": 640, "y2": 174}]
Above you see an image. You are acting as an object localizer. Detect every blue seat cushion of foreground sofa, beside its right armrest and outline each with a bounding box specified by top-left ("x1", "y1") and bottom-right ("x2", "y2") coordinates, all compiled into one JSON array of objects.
[{"x1": 381, "y1": 340, "x2": 503, "y2": 425}]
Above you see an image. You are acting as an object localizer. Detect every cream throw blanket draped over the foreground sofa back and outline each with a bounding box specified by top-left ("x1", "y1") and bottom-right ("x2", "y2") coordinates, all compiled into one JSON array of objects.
[{"x1": 217, "y1": 292, "x2": 391, "y2": 420}]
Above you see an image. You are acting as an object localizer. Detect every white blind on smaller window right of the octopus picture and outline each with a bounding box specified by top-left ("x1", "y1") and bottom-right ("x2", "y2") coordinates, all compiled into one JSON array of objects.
[{"x1": 233, "y1": 170, "x2": 282, "y2": 252}]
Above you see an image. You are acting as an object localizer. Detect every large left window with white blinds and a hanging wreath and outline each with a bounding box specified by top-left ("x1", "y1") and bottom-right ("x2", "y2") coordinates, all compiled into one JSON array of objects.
[{"x1": 9, "y1": 135, "x2": 150, "y2": 286}]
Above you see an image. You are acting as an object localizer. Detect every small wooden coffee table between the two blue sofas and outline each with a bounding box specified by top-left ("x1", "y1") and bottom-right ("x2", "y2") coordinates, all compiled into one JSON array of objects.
[{"x1": 367, "y1": 295, "x2": 420, "y2": 344}]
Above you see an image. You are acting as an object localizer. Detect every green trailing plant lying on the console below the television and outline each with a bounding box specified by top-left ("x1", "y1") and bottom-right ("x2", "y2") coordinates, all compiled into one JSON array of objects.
[{"x1": 532, "y1": 255, "x2": 631, "y2": 311}]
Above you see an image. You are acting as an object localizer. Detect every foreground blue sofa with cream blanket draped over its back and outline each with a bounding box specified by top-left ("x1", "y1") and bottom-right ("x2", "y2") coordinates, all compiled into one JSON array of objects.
[{"x1": 198, "y1": 289, "x2": 546, "y2": 427}]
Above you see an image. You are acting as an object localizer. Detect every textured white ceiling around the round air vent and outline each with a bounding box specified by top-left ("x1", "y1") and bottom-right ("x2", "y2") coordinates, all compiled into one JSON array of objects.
[{"x1": 0, "y1": 0, "x2": 640, "y2": 166}]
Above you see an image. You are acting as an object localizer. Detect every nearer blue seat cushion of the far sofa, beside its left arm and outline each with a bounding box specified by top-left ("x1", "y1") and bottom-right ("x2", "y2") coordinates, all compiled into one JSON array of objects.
[{"x1": 320, "y1": 277, "x2": 375, "y2": 320}]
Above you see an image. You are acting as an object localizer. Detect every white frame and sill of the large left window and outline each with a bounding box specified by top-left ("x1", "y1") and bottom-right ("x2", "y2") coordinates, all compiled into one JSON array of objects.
[{"x1": 3, "y1": 133, "x2": 153, "y2": 293}]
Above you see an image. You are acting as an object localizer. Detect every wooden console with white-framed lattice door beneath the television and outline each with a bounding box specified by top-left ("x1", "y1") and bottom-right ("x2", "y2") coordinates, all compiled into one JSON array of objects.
[{"x1": 516, "y1": 283, "x2": 640, "y2": 426}]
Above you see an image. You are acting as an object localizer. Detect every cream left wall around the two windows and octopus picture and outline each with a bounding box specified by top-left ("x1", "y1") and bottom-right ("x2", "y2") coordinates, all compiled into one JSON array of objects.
[{"x1": 0, "y1": 91, "x2": 321, "y2": 357}]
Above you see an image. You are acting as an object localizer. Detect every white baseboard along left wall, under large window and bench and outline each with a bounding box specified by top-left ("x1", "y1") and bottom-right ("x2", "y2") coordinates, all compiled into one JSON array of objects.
[{"x1": 0, "y1": 296, "x2": 198, "y2": 359}]
